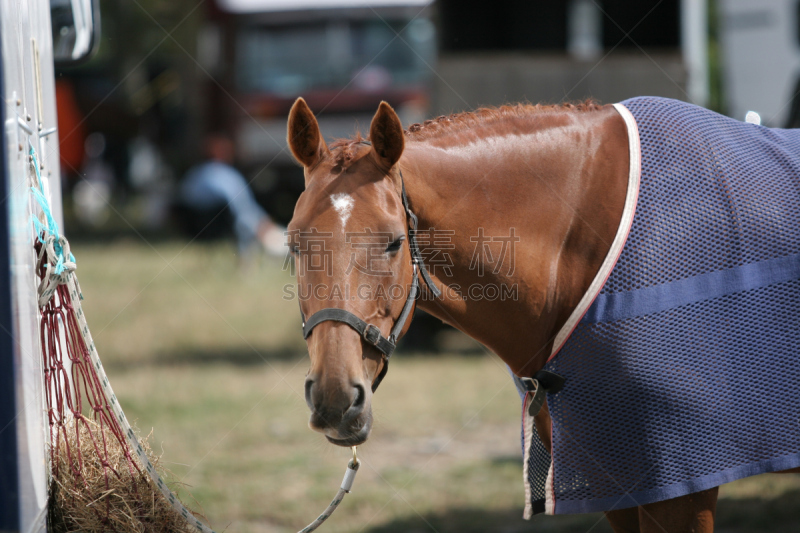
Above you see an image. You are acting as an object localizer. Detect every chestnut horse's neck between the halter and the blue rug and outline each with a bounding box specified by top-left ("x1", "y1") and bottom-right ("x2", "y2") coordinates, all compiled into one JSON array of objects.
[{"x1": 400, "y1": 107, "x2": 628, "y2": 376}]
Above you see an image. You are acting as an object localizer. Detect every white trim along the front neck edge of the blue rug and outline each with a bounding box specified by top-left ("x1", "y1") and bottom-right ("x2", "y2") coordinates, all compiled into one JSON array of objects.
[{"x1": 548, "y1": 104, "x2": 642, "y2": 361}]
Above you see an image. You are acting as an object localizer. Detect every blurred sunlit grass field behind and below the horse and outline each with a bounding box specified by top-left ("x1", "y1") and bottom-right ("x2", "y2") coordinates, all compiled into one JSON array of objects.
[{"x1": 73, "y1": 241, "x2": 800, "y2": 533}]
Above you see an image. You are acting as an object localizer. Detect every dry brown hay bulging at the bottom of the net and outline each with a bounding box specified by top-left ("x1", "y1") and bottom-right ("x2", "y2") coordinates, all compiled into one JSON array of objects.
[{"x1": 48, "y1": 418, "x2": 205, "y2": 533}]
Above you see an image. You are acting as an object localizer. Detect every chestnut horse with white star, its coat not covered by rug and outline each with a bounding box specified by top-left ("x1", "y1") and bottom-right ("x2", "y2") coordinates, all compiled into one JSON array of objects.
[{"x1": 288, "y1": 98, "x2": 800, "y2": 532}]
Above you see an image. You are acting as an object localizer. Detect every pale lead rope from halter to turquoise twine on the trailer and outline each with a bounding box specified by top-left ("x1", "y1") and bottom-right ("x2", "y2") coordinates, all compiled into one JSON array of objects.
[{"x1": 28, "y1": 145, "x2": 361, "y2": 533}]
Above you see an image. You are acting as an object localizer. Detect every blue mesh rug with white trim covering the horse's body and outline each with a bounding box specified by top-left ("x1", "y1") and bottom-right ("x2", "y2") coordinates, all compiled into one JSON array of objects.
[{"x1": 523, "y1": 98, "x2": 800, "y2": 517}]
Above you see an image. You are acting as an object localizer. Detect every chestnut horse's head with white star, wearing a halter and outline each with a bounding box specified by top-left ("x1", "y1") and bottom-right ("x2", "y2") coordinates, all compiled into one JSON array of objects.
[{"x1": 288, "y1": 98, "x2": 417, "y2": 446}]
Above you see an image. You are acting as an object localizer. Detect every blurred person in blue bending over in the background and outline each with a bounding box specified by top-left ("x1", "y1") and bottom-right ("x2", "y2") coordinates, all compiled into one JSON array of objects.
[{"x1": 178, "y1": 134, "x2": 285, "y2": 256}]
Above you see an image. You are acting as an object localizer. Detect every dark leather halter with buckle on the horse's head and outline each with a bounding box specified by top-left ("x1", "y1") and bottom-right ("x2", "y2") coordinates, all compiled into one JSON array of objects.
[{"x1": 300, "y1": 141, "x2": 442, "y2": 392}]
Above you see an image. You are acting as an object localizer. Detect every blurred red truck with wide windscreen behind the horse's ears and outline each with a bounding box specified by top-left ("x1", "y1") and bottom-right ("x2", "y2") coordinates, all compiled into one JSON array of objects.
[{"x1": 203, "y1": 0, "x2": 436, "y2": 223}]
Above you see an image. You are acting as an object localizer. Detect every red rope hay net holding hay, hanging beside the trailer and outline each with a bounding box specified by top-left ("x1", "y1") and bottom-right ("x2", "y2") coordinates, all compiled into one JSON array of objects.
[{"x1": 36, "y1": 234, "x2": 211, "y2": 533}]
